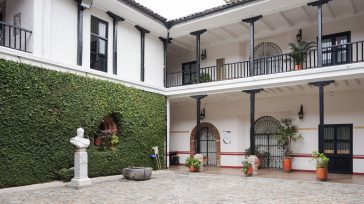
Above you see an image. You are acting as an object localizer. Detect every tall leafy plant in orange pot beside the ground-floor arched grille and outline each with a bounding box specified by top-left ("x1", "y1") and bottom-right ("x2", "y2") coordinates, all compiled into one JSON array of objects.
[{"x1": 277, "y1": 118, "x2": 303, "y2": 173}]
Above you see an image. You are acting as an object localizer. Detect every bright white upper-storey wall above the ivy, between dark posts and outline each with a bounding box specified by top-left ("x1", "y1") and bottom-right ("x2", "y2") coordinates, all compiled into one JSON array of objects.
[{"x1": 2, "y1": 0, "x2": 163, "y2": 88}]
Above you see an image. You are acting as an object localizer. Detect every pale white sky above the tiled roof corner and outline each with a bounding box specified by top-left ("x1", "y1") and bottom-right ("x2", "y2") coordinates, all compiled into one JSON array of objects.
[{"x1": 136, "y1": 0, "x2": 225, "y2": 20}]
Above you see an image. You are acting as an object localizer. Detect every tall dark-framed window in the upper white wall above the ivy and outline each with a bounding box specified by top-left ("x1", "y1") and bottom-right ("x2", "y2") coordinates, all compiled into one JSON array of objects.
[{"x1": 90, "y1": 16, "x2": 108, "y2": 72}]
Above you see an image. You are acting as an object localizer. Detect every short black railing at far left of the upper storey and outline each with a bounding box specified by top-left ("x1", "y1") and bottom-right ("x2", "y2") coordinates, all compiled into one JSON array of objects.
[{"x1": 0, "y1": 22, "x2": 32, "y2": 52}]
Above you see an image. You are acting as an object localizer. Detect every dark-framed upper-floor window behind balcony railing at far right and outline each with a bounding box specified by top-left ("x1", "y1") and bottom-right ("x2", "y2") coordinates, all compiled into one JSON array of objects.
[{"x1": 322, "y1": 32, "x2": 351, "y2": 66}]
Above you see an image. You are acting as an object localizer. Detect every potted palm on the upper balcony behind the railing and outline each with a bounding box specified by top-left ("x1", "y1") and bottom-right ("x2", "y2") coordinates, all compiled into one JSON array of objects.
[{"x1": 288, "y1": 41, "x2": 315, "y2": 70}]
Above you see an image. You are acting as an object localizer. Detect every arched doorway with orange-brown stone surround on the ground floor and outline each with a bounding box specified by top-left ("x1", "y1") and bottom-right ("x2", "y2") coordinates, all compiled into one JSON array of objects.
[{"x1": 190, "y1": 123, "x2": 221, "y2": 167}]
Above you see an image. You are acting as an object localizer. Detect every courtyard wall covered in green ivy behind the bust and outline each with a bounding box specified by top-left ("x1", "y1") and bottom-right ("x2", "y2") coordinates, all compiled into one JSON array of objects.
[{"x1": 0, "y1": 60, "x2": 166, "y2": 188}]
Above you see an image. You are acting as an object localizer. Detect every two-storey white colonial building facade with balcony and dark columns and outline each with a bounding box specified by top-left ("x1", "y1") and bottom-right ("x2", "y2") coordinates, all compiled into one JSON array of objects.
[{"x1": 0, "y1": 0, "x2": 364, "y2": 174}]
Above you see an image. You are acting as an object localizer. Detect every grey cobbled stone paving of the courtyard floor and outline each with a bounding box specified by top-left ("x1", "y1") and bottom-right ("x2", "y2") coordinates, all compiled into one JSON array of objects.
[{"x1": 0, "y1": 171, "x2": 364, "y2": 204}]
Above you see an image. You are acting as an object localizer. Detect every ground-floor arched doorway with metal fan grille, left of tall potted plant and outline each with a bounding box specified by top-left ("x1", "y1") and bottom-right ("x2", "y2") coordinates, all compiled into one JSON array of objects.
[{"x1": 255, "y1": 116, "x2": 283, "y2": 168}]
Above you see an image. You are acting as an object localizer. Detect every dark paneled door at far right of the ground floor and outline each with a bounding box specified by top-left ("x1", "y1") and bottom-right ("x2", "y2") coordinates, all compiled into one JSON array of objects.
[{"x1": 319, "y1": 124, "x2": 353, "y2": 174}]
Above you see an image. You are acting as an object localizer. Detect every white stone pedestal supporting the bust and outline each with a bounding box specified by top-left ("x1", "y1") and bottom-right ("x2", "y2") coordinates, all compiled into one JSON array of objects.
[{"x1": 68, "y1": 148, "x2": 92, "y2": 189}]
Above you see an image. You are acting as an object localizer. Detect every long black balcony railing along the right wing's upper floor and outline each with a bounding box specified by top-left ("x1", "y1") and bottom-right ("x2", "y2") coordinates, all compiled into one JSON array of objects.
[{"x1": 167, "y1": 41, "x2": 364, "y2": 87}]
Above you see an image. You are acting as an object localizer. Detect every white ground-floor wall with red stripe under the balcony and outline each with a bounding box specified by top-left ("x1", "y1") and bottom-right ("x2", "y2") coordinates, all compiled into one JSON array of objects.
[{"x1": 170, "y1": 90, "x2": 364, "y2": 173}]
